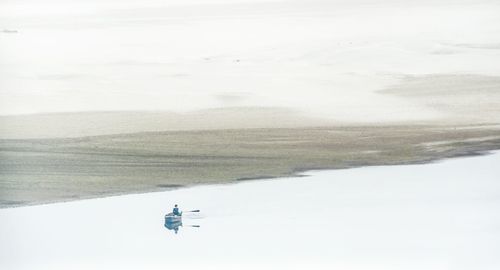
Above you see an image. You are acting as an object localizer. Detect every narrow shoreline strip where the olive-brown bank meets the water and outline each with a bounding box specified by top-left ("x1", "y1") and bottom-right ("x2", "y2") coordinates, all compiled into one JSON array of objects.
[{"x1": 0, "y1": 132, "x2": 500, "y2": 210}]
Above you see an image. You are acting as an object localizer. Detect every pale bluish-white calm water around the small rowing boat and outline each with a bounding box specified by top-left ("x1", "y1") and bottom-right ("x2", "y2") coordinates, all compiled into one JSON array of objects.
[{"x1": 0, "y1": 152, "x2": 500, "y2": 270}]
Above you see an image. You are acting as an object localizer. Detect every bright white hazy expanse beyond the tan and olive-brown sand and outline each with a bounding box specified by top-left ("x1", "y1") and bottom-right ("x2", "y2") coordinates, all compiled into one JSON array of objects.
[{"x1": 0, "y1": 0, "x2": 500, "y2": 122}]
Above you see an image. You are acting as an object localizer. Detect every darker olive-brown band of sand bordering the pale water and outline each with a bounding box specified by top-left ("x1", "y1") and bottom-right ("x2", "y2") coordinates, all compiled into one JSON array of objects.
[{"x1": 0, "y1": 125, "x2": 500, "y2": 208}]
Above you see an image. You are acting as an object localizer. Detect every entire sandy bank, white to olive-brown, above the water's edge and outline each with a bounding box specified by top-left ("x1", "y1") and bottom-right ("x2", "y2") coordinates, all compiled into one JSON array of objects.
[{"x1": 0, "y1": 0, "x2": 500, "y2": 207}]
